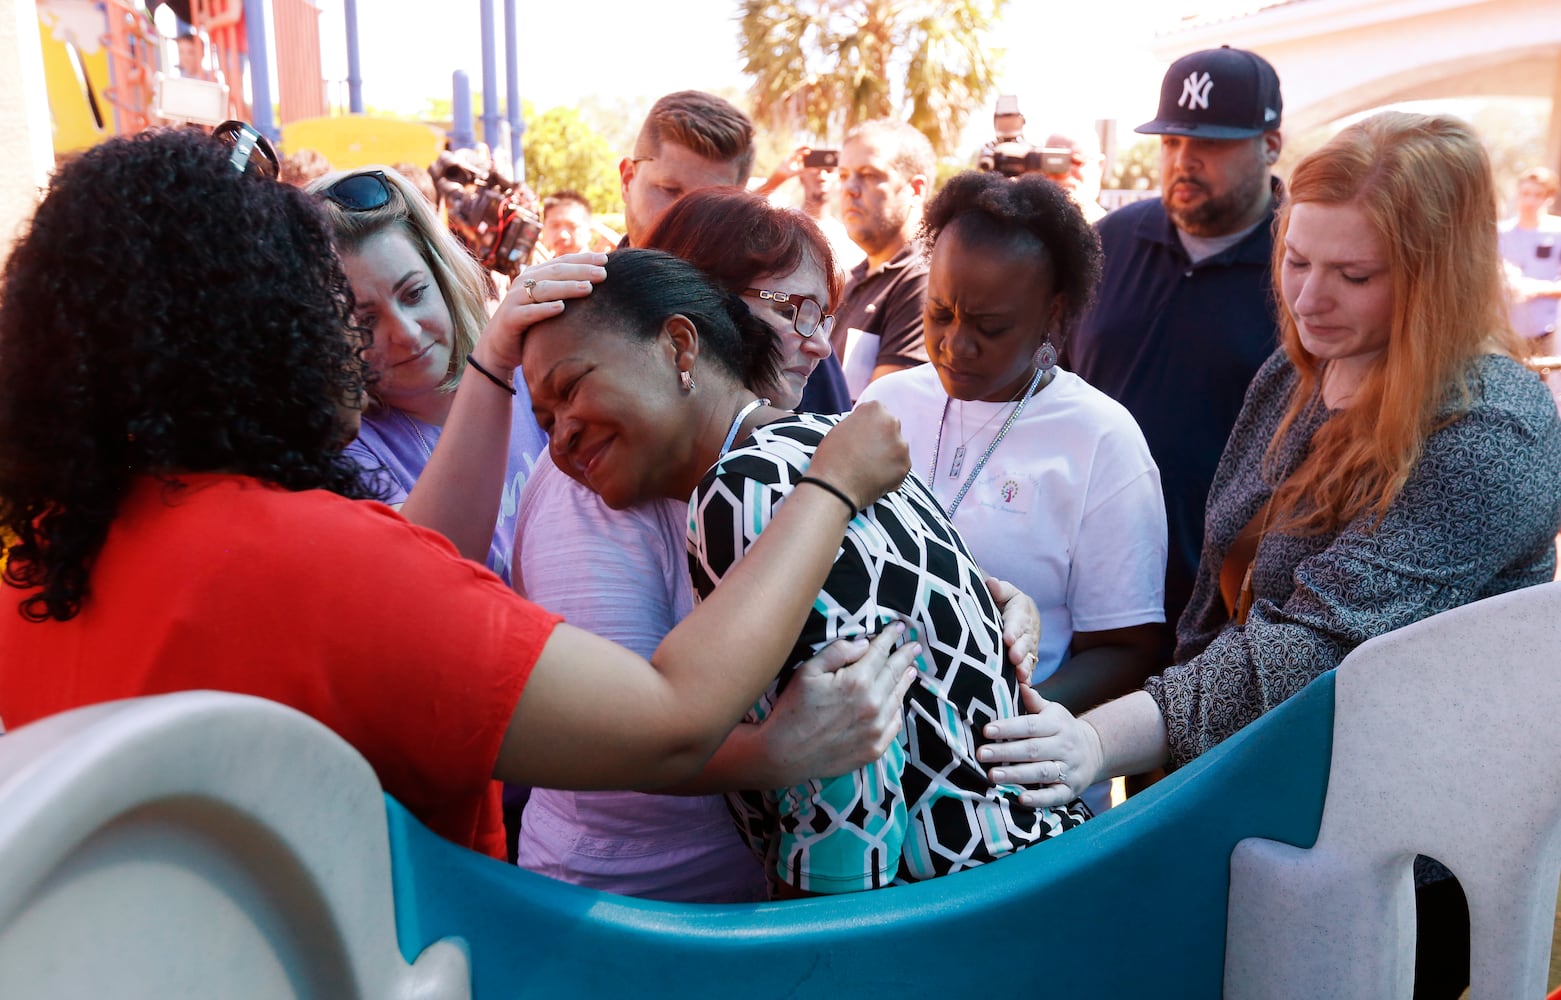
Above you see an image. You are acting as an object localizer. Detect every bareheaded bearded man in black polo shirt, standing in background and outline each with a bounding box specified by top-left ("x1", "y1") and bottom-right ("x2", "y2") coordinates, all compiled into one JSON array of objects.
[{"x1": 830, "y1": 119, "x2": 937, "y2": 401}]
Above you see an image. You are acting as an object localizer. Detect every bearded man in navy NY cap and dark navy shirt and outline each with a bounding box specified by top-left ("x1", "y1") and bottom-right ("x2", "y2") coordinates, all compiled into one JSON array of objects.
[{"x1": 1063, "y1": 47, "x2": 1282, "y2": 639}]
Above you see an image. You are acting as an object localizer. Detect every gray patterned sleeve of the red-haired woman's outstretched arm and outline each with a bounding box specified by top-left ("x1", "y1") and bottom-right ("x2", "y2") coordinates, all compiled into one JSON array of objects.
[{"x1": 1146, "y1": 397, "x2": 1561, "y2": 764}]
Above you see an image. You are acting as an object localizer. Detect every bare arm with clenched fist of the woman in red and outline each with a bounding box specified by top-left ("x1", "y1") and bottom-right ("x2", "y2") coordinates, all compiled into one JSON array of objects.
[{"x1": 498, "y1": 397, "x2": 910, "y2": 788}]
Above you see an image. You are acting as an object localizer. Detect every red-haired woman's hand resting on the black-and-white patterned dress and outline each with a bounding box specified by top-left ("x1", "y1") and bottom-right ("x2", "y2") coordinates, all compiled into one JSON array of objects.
[{"x1": 976, "y1": 686, "x2": 1104, "y2": 807}]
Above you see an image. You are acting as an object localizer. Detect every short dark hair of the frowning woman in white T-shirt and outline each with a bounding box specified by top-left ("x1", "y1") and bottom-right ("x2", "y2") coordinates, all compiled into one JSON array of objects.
[{"x1": 921, "y1": 170, "x2": 1101, "y2": 334}]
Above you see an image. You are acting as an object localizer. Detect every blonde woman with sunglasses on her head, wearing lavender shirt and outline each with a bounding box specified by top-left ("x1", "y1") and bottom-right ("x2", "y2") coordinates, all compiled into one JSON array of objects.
[{"x1": 308, "y1": 167, "x2": 574, "y2": 580}]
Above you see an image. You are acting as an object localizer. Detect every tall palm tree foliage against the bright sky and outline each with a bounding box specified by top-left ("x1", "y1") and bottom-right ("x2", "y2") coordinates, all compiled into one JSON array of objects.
[{"x1": 740, "y1": 0, "x2": 1007, "y2": 156}]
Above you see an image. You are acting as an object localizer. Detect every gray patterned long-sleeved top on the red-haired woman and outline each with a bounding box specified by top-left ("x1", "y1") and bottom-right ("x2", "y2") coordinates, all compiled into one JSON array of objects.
[{"x1": 1144, "y1": 349, "x2": 1561, "y2": 766}]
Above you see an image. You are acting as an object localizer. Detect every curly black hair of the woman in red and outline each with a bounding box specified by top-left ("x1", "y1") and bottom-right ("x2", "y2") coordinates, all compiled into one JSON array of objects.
[{"x1": 0, "y1": 129, "x2": 368, "y2": 621}]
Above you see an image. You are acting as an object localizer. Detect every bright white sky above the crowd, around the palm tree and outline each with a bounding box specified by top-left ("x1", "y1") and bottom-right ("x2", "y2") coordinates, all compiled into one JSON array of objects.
[{"x1": 317, "y1": 0, "x2": 1217, "y2": 142}]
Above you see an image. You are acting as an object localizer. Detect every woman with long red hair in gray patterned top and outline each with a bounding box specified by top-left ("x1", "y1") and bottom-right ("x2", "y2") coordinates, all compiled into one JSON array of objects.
[{"x1": 983, "y1": 112, "x2": 1561, "y2": 997}]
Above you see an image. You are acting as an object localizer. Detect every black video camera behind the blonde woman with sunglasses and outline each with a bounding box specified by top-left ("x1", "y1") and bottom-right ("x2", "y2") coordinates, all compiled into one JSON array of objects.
[{"x1": 429, "y1": 150, "x2": 542, "y2": 278}]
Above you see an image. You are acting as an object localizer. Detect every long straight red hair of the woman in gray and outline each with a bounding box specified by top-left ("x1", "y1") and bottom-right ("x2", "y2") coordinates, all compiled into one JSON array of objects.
[{"x1": 1269, "y1": 111, "x2": 1520, "y2": 534}]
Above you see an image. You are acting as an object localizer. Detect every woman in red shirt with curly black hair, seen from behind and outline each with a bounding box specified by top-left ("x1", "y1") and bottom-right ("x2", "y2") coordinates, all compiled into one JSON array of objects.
[{"x1": 0, "y1": 129, "x2": 913, "y2": 852}]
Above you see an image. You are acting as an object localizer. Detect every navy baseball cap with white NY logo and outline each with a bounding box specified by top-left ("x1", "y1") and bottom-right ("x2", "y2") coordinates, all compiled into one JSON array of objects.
[{"x1": 1133, "y1": 45, "x2": 1283, "y2": 139}]
